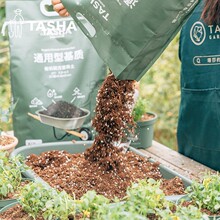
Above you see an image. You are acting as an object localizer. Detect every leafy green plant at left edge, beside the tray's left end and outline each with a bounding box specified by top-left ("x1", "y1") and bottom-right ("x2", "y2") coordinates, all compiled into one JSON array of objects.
[{"x1": 0, "y1": 151, "x2": 26, "y2": 199}]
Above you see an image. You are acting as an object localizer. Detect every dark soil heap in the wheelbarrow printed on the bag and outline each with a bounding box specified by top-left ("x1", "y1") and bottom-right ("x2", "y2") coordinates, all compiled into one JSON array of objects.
[{"x1": 39, "y1": 101, "x2": 86, "y2": 118}]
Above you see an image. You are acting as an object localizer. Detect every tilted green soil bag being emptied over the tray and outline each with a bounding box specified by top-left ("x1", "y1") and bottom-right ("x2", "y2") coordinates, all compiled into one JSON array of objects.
[{"x1": 62, "y1": 0, "x2": 199, "y2": 81}]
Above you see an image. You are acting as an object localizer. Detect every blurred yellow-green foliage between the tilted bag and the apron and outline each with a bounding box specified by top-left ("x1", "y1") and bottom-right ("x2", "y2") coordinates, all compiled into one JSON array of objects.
[{"x1": 140, "y1": 37, "x2": 180, "y2": 150}]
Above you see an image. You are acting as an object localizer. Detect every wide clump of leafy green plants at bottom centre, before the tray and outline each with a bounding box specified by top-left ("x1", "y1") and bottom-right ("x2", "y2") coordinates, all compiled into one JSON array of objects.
[{"x1": 80, "y1": 179, "x2": 208, "y2": 220}]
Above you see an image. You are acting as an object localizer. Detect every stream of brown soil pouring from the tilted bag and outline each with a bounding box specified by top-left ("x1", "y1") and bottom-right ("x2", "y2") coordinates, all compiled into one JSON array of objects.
[{"x1": 85, "y1": 73, "x2": 135, "y2": 171}]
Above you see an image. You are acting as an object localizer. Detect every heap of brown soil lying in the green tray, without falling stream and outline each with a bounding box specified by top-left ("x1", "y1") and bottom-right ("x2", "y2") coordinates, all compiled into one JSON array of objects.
[{"x1": 26, "y1": 150, "x2": 184, "y2": 199}]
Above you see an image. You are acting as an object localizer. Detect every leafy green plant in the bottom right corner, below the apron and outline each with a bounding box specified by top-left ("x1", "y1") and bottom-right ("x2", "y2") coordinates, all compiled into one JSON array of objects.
[{"x1": 186, "y1": 173, "x2": 220, "y2": 214}]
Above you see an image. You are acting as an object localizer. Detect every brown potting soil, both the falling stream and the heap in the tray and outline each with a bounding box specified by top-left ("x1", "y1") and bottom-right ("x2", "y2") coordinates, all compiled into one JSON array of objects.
[{"x1": 24, "y1": 74, "x2": 184, "y2": 199}]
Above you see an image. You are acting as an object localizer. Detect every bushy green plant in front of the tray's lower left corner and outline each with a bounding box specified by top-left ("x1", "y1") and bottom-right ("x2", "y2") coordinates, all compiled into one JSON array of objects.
[{"x1": 19, "y1": 182, "x2": 76, "y2": 220}]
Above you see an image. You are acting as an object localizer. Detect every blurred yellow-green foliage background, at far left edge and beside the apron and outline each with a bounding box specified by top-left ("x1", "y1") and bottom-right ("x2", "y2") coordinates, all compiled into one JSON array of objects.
[{"x1": 0, "y1": 0, "x2": 180, "y2": 150}]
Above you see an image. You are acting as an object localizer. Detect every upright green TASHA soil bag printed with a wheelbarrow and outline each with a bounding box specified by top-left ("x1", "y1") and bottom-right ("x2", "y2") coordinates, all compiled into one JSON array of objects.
[{"x1": 2, "y1": 0, "x2": 107, "y2": 146}]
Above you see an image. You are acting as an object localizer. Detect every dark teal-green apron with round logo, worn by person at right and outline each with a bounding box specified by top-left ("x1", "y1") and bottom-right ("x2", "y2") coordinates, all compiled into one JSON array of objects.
[{"x1": 177, "y1": 0, "x2": 220, "y2": 170}]
